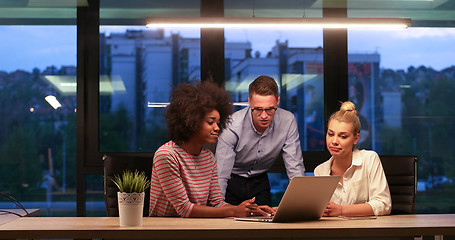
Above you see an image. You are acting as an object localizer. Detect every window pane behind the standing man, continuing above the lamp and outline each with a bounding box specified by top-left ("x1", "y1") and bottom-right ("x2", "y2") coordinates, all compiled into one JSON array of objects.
[{"x1": 224, "y1": 0, "x2": 325, "y2": 151}]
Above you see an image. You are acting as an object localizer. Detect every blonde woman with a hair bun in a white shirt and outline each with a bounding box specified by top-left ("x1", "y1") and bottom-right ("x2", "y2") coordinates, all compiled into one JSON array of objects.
[{"x1": 314, "y1": 101, "x2": 392, "y2": 216}]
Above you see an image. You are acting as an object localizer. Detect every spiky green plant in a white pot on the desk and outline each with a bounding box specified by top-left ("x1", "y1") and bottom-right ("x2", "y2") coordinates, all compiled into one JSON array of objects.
[{"x1": 112, "y1": 170, "x2": 150, "y2": 226}]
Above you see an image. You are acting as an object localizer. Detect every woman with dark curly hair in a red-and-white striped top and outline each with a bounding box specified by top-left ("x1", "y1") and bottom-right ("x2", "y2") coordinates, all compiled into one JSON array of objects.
[{"x1": 149, "y1": 81, "x2": 274, "y2": 217}]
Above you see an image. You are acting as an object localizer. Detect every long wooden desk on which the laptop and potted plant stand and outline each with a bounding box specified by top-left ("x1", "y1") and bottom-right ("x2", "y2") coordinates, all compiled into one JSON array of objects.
[{"x1": 0, "y1": 214, "x2": 455, "y2": 239}]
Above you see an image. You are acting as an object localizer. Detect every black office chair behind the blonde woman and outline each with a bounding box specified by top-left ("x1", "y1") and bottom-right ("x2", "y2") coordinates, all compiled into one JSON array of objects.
[{"x1": 379, "y1": 155, "x2": 417, "y2": 214}]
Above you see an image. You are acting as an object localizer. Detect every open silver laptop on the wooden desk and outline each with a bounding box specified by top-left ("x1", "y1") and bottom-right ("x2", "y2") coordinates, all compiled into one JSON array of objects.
[{"x1": 234, "y1": 176, "x2": 341, "y2": 222}]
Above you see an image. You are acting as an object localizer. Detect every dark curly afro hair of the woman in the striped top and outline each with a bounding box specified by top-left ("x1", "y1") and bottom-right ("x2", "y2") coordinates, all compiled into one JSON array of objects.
[{"x1": 165, "y1": 81, "x2": 233, "y2": 141}]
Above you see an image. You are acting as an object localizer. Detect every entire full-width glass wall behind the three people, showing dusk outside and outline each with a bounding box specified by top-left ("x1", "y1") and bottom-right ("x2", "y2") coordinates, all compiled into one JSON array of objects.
[{"x1": 0, "y1": 0, "x2": 455, "y2": 216}]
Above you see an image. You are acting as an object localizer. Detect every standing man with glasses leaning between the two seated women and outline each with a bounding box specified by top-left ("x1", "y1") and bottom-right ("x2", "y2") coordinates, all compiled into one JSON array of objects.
[{"x1": 215, "y1": 76, "x2": 305, "y2": 206}]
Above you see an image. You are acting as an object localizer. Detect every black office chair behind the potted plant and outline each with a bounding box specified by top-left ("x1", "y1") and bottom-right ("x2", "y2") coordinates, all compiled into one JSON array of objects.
[{"x1": 103, "y1": 154, "x2": 153, "y2": 217}]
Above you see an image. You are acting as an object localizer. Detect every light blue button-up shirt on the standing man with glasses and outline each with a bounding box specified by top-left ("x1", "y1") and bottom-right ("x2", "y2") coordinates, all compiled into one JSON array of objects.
[{"x1": 216, "y1": 107, "x2": 305, "y2": 196}]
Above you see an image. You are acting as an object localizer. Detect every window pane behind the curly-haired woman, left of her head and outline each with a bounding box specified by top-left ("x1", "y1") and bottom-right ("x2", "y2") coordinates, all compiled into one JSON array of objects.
[{"x1": 100, "y1": 26, "x2": 201, "y2": 153}]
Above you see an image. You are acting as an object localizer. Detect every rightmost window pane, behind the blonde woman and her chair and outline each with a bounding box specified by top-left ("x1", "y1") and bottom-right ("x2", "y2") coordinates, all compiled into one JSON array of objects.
[{"x1": 348, "y1": 28, "x2": 455, "y2": 213}]
